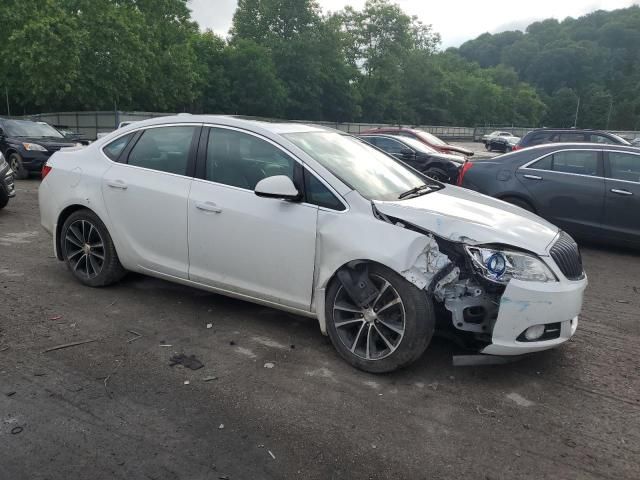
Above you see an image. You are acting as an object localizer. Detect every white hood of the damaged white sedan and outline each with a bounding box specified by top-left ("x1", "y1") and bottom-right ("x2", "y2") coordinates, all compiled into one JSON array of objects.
[{"x1": 374, "y1": 186, "x2": 559, "y2": 255}]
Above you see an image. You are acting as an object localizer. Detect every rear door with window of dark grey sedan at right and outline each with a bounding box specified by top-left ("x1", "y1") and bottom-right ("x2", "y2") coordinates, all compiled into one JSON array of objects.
[{"x1": 516, "y1": 149, "x2": 605, "y2": 235}]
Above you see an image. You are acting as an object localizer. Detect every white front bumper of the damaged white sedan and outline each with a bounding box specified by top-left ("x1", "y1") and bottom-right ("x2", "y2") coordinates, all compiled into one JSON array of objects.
[{"x1": 481, "y1": 277, "x2": 588, "y2": 355}]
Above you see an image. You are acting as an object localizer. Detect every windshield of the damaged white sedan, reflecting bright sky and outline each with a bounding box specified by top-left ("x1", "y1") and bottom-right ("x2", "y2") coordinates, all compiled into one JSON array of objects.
[{"x1": 284, "y1": 132, "x2": 428, "y2": 200}]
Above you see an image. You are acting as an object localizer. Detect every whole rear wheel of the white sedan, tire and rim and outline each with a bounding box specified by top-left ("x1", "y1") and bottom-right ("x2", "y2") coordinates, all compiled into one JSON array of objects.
[{"x1": 60, "y1": 209, "x2": 126, "y2": 287}]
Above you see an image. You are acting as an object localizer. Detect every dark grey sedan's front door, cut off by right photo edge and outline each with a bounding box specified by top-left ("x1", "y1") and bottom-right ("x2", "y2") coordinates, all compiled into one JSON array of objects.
[{"x1": 604, "y1": 151, "x2": 640, "y2": 243}]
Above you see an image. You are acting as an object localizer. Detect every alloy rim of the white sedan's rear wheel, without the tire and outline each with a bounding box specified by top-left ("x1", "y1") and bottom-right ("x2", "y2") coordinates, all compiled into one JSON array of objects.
[{"x1": 64, "y1": 220, "x2": 105, "y2": 279}]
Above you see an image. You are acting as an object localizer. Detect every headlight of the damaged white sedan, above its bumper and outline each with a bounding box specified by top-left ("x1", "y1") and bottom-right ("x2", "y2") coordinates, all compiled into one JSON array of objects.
[{"x1": 465, "y1": 246, "x2": 557, "y2": 284}]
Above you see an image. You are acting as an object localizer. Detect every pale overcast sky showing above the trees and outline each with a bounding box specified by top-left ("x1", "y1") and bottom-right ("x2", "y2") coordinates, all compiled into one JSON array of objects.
[{"x1": 189, "y1": 0, "x2": 640, "y2": 48}]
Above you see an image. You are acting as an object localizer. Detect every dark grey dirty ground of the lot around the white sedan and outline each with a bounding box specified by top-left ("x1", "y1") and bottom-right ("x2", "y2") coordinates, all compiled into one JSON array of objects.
[{"x1": 0, "y1": 180, "x2": 640, "y2": 480}]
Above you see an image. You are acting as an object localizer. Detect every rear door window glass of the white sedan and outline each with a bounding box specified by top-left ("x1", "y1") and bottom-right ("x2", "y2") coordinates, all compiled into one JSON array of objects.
[{"x1": 127, "y1": 126, "x2": 197, "y2": 175}]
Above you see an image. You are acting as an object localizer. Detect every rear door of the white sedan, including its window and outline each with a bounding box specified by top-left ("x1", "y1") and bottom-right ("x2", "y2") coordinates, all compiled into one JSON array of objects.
[{"x1": 102, "y1": 126, "x2": 200, "y2": 279}]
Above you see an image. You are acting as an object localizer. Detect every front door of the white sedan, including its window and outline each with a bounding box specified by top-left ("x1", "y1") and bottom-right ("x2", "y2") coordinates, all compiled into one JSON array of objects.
[{"x1": 188, "y1": 128, "x2": 318, "y2": 310}]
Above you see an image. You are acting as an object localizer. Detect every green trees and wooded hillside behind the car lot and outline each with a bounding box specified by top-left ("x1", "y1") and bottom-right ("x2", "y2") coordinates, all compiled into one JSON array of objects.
[{"x1": 0, "y1": 0, "x2": 640, "y2": 129}]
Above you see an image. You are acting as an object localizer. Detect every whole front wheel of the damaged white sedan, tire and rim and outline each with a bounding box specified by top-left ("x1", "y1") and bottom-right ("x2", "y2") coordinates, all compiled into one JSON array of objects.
[{"x1": 325, "y1": 264, "x2": 436, "y2": 373}]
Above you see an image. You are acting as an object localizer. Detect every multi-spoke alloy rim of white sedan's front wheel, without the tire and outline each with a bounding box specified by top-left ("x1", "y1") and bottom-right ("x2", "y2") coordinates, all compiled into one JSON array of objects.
[{"x1": 333, "y1": 275, "x2": 406, "y2": 360}]
